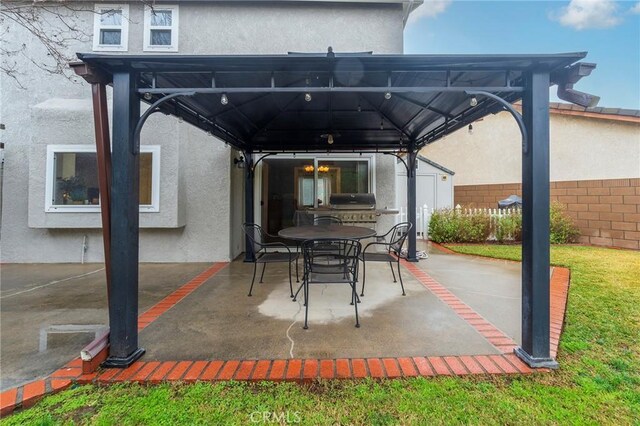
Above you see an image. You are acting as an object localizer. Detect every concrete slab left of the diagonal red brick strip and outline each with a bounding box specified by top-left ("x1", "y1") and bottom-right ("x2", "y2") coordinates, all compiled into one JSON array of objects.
[{"x1": 0, "y1": 263, "x2": 208, "y2": 390}]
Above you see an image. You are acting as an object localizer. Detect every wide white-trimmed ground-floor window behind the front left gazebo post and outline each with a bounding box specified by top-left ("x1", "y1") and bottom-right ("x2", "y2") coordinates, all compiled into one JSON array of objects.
[{"x1": 45, "y1": 145, "x2": 160, "y2": 213}]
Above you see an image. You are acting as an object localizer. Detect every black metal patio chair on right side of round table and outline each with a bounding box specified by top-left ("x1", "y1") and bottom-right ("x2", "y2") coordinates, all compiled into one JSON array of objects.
[{"x1": 360, "y1": 222, "x2": 412, "y2": 296}]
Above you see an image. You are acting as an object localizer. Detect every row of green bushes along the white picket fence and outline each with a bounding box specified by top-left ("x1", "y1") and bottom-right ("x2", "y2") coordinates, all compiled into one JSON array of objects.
[{"x1": 429, "y1": 202, "x2": 580, "y2": 244}]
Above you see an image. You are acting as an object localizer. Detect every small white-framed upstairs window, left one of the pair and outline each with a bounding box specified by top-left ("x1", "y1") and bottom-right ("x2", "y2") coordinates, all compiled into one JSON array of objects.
[{"x1": 93, "y1": 4, "x2": 129, "y2": 52}]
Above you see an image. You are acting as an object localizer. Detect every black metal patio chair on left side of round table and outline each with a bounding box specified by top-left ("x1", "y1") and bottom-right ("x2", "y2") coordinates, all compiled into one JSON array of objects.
[{"x1": 242, "y1": 223, "x2": 300, "y2": 297}]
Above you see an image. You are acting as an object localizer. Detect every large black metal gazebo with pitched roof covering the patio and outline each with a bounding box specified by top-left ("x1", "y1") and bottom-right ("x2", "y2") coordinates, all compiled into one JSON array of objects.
[{"x1": 72, "y1": 48, "x2": 598, "y2": 367}]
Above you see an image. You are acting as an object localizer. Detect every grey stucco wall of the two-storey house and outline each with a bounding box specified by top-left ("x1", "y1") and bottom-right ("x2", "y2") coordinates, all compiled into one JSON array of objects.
[{"x1": 0, "y1": 2, "x2": 403, "y2": 262}]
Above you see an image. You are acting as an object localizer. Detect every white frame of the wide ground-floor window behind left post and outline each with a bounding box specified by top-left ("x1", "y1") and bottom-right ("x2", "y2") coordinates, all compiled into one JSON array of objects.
[{"x1": 44, "y1": 145, "x2": 160, "y2": 213}]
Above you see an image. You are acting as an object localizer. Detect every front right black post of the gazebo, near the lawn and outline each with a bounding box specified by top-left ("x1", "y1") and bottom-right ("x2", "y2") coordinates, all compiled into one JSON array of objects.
[{"x1": 515, "y1": 70, "x2": 558, "y2": 368}]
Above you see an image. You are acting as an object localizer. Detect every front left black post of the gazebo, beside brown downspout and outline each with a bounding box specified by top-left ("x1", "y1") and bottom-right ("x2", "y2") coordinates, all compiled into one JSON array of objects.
[{"x1": 104, "y1": 72, "x2": 144, "y2": 368}]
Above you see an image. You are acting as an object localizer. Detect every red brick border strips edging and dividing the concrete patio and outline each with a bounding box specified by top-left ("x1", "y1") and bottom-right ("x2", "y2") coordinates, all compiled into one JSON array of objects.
[{"x1": 0, "y1": 252, "x2": 570, "y2": 416}]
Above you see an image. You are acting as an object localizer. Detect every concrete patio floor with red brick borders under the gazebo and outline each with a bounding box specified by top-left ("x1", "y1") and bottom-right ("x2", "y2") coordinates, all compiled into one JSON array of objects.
[{"x1": 0, "y1": 248, "x2": 570, "y2": 416}]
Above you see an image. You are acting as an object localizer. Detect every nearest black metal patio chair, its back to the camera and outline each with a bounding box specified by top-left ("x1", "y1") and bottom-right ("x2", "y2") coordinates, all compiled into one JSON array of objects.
[{"x1": 294, "y1": 239, "x2": 362, "y2": 329}]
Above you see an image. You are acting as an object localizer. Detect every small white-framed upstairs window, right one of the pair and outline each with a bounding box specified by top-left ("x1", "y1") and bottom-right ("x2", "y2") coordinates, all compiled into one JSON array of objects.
[{"x1": 144, "y1": 4, "x2": 179, "y2": 52}]
